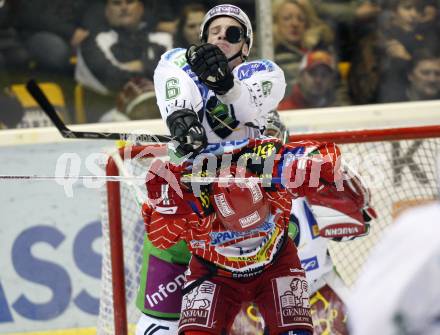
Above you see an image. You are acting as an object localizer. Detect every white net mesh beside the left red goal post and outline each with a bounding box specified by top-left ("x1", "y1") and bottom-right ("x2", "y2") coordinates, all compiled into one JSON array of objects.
[{"x1": 97, "y1": 148, "x2": 167, "y2": 335}]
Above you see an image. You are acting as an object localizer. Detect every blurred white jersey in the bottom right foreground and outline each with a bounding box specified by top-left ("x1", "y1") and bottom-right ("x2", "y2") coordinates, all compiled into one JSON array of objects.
[{"x1": 348, "y1": 202, "x2": 440, "y2": 335}]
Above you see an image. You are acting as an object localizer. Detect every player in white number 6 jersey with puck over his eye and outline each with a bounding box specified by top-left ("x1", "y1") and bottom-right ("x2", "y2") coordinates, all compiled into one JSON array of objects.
[{"x1": 154, "y1": 5, "x2": 286, "y2": 154}]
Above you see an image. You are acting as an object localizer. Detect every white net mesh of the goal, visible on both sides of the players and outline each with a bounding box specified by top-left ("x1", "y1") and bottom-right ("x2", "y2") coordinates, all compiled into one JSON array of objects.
[{"x1": 98, "y1": 135, "x2": 440, "y2": 334}]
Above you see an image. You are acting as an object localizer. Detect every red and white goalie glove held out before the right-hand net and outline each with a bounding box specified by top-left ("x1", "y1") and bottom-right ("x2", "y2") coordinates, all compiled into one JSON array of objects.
[{"x1": 307, "y1": 174, "x2": 377, "y2": 241}]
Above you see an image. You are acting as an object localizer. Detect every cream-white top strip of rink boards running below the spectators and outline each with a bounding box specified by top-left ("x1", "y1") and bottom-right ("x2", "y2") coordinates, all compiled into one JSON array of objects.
[{"x1": 0, "y1": 100, "x2": 440, "y2": 146}]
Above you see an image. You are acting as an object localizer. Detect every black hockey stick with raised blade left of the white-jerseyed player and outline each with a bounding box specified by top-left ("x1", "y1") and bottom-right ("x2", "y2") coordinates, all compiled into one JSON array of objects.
[{"x1": 26, "y1": 79, "x2": 173, "y2": 143}]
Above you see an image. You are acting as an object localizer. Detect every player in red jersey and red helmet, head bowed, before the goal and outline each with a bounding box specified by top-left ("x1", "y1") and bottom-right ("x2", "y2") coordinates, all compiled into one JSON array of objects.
[{"x1": 143, "y1": 139, "x2": 372, "y2": 334}]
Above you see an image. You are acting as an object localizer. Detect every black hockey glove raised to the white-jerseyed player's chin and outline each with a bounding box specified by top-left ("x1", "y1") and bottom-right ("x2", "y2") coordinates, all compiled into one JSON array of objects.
[{"x1": 186, "y1": 43, "x2": 234, "y2": 94}]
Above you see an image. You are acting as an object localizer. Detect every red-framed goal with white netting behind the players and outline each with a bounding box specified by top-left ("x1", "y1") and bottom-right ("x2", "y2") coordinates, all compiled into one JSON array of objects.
[{"x1": 98, "y1": 126, "x2": 440, "y2": 335}]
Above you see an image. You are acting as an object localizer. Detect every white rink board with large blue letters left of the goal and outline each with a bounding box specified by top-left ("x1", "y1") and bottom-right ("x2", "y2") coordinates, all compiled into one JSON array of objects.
[{"x1": 0, "y1": 140, "x2": 112, "y2": 334}]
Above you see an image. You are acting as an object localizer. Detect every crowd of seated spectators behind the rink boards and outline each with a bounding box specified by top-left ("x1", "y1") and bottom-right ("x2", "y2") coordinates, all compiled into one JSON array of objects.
[{"x1": 0, "y1": 0, "x2": 440, "y2": 127}]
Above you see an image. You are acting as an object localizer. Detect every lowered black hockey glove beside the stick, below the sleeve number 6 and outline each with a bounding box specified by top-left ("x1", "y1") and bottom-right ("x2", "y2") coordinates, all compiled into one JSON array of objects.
[{"x1": 167, "y1": 108, "x2": 208, "y2": 156}]
